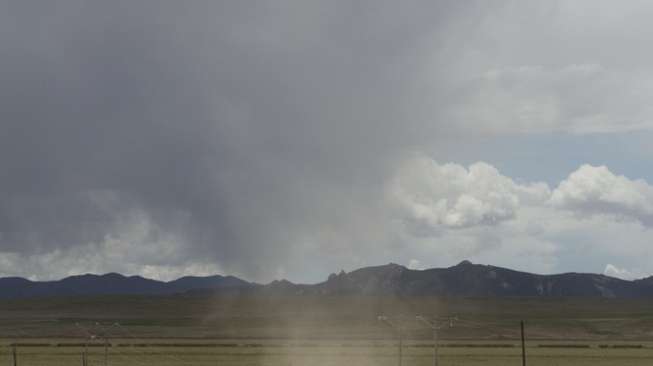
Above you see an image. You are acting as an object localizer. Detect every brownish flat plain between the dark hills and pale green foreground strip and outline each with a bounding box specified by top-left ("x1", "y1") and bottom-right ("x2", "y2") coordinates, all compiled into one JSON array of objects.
[{"x1": 0, "y1": 294, "x2": 653, "y2": 342}]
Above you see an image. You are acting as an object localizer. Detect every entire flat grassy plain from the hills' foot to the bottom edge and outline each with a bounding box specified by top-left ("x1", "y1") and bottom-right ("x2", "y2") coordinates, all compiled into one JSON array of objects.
[{"x1": 0, "y1": 294, "x2": 653, "y2": 366}]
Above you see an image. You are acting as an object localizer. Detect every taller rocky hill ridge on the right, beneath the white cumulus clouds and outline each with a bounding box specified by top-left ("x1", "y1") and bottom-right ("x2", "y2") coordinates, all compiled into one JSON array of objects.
[{"x1": 297, "y1": 261, "x2": 653, "y2": 298}]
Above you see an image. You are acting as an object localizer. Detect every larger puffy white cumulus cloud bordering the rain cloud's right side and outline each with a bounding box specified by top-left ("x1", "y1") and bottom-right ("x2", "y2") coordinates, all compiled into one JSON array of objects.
[{"x1": 390, "y1": 156, "x2": 550, "y2": 231}]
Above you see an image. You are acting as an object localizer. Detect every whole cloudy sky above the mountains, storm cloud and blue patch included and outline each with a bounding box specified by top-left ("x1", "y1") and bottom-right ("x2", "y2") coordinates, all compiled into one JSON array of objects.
[{"x1": 0, "y1": 0, "x2": 653, "y2": 283}]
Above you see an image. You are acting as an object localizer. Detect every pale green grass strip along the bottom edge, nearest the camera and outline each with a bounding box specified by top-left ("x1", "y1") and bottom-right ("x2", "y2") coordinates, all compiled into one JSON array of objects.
[{"x1": 0, "y1": 342, "x2": 653, "y2": 366}]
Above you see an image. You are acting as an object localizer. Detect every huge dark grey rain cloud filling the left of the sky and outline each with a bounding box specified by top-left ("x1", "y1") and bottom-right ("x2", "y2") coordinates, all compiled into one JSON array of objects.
[{"x1": 0, "y1": 1, "x2": 473, "y2": 277}]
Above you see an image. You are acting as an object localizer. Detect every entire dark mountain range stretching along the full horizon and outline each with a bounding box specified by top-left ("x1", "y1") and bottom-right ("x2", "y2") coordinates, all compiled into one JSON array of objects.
[{"x1": 0, "y1": 261, "x2": 653, "y2": 299}]
